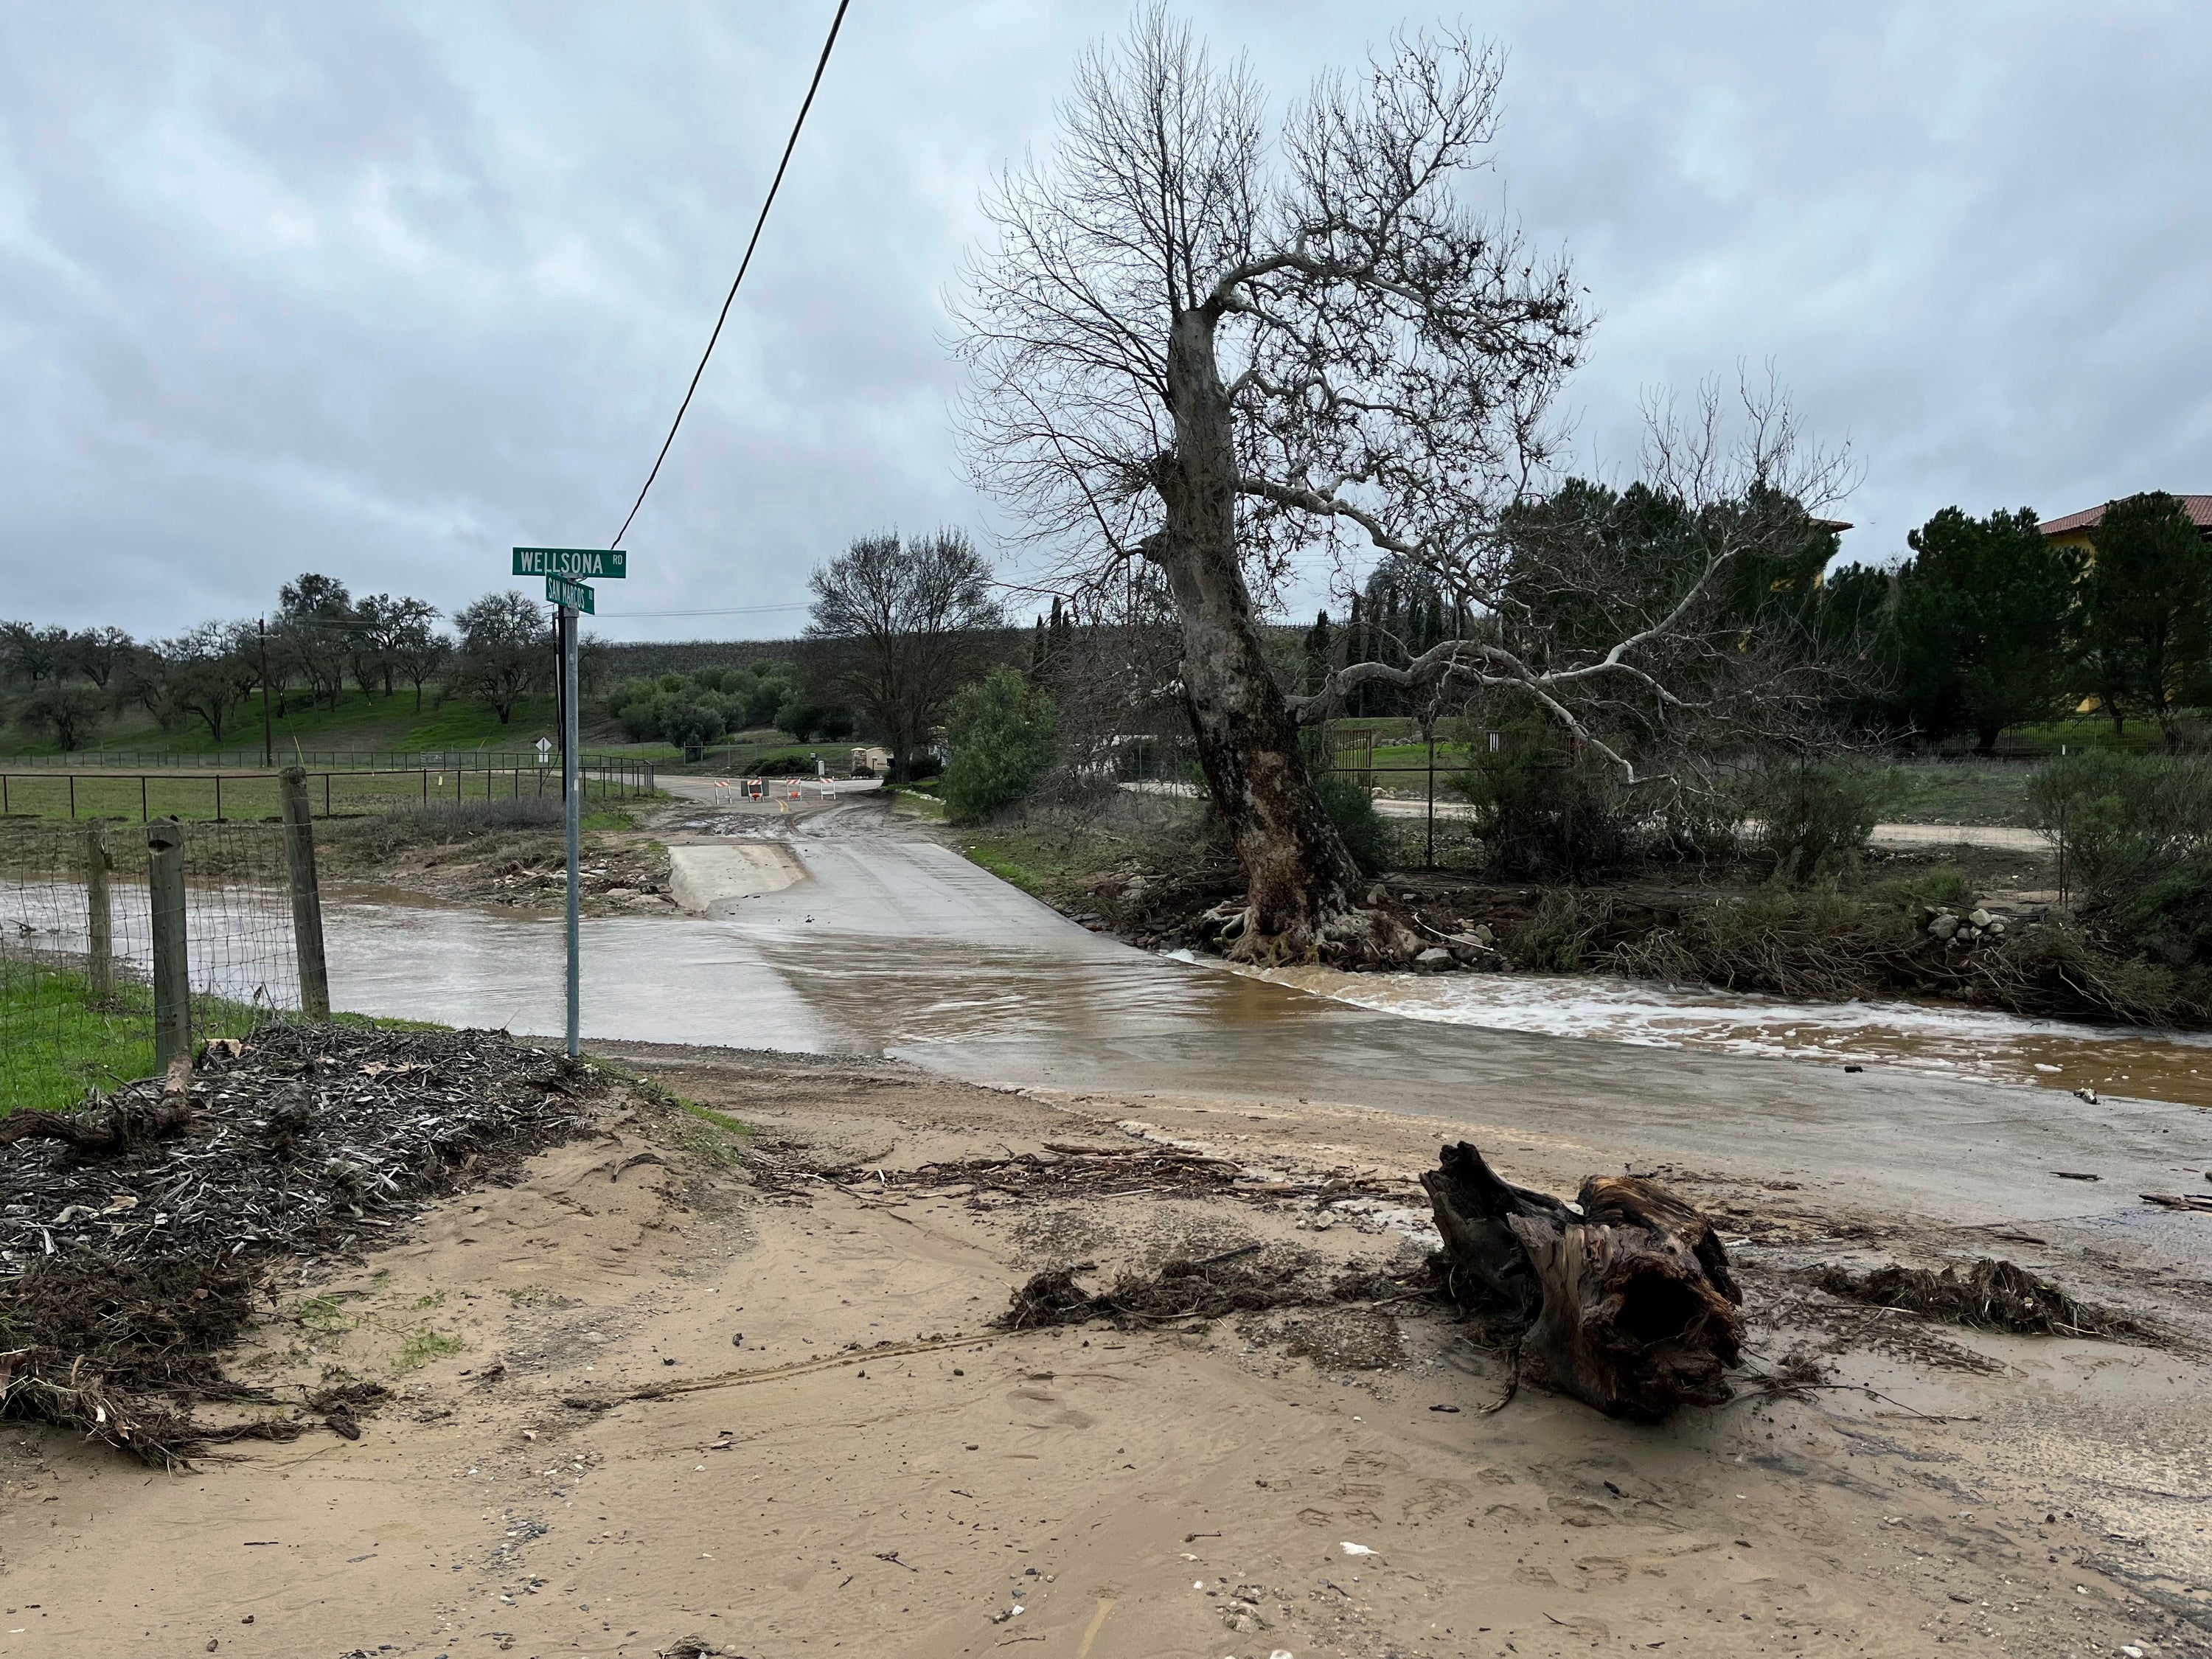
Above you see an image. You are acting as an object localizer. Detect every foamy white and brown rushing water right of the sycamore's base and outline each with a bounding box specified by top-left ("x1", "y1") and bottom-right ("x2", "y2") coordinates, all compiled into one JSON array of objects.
[{"x1": 1239, "y1": 967, "x2": 2212, "y2": 1106}]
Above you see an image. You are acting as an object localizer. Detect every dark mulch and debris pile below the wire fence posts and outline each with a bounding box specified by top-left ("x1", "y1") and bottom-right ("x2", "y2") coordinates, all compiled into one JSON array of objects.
[{"x1": 0, "y1": 1024, "x2": 602, "y2": 1467}]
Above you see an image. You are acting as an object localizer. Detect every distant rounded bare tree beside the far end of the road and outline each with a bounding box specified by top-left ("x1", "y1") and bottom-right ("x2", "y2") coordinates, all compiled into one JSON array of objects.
[{"x1": 807, "y1": 529, "x2": 1006, "y2": 779}]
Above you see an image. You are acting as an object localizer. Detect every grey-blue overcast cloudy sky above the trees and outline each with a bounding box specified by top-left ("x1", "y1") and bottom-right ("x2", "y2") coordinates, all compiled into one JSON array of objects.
[{"x1": 0, "y1": 0, "x2": 2212, "y2": 639}]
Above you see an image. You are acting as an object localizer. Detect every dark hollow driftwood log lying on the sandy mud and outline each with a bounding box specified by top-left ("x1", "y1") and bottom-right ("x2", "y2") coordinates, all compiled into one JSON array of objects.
[{"x1": 1420, "y1": 1141, "x2": 1743, "y2": 1420}]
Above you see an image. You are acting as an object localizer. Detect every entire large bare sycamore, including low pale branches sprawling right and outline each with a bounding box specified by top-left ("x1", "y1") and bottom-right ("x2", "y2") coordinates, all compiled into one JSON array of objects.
[{"x1": 960, "y1": 9, "x2": 1845, "y2": 958}]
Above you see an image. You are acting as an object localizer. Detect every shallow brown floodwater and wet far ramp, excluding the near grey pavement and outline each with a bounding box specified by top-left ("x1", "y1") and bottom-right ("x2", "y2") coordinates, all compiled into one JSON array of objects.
[{"x1": 316, "y1": 814, "x2": 2212, "y2": 1106}]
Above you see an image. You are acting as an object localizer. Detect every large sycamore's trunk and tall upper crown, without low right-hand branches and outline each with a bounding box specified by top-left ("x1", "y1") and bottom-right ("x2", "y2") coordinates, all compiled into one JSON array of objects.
[{"x1": 962, "y1": 11, "x2": 1586, "y2": 956}]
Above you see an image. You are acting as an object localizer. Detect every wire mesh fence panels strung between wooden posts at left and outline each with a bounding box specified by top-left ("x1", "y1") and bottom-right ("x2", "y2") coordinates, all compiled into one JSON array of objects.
[{"x1": 0, "y1": 823, "x2": 299, "y2": 1113}]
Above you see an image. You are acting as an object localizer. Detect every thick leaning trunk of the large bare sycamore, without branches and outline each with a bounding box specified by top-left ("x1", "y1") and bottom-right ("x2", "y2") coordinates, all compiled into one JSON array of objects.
[{"x1": 1155, "y1": 310, "x2": 1371, "y2": 960}]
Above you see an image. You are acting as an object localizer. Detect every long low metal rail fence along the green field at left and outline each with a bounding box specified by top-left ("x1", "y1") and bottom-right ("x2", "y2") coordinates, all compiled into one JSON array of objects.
[{"x1": 0, "y1": 754, "x2": 655, "y2": 823}]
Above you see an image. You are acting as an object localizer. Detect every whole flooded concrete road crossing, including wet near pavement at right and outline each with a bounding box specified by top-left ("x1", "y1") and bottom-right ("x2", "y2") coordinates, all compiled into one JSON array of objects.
[{"x1": 312, "y1": 803, "x2": 2212, "y2": 1252}]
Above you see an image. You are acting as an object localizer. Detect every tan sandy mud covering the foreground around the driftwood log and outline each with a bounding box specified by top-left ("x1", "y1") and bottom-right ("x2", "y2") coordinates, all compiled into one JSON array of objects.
[{"x1": 0, "y1": 1048, "x2": 2212, "y2": 1659}]
